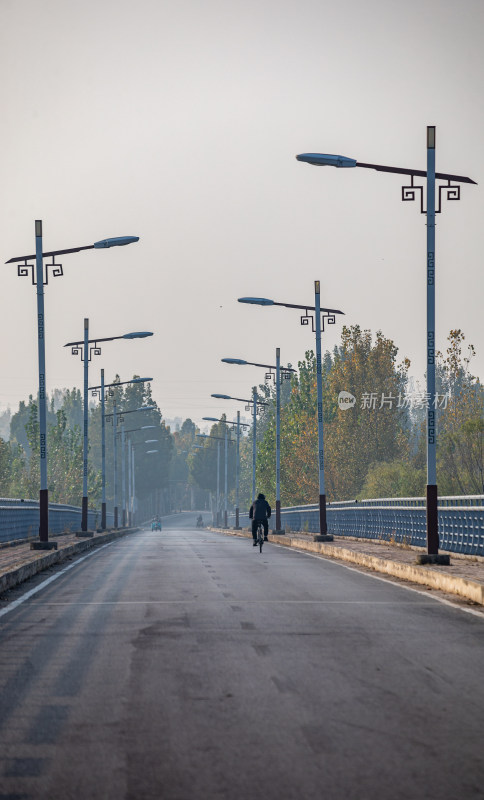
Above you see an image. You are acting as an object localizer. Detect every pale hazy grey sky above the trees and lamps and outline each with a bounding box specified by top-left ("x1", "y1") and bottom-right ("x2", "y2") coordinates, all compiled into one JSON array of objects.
[{"x1": 0, "y1": 0, "x2": 484, "y2": 432}]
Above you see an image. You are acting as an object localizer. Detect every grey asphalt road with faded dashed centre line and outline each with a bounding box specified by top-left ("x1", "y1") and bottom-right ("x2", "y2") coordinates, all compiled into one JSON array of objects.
[{"x1": 0, "y1": 515, "x2": 484, "y2": 800}]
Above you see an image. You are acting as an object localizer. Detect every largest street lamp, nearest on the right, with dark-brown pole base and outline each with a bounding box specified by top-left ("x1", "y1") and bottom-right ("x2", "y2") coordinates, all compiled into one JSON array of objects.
[{"x1": 296, "y1": 125, "x2": 476, "y2": 564}]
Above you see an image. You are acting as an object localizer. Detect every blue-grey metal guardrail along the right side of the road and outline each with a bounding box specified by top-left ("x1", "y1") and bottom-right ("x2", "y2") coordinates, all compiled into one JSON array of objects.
[{"x1": 230, "y1": 495, "x2": 484, "y2": 556}]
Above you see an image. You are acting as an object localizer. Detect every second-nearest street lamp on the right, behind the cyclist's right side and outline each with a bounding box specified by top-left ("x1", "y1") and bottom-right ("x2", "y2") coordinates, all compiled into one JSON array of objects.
[{"x1": 239, "y1": 288, "x2": 343, "y2": 542}]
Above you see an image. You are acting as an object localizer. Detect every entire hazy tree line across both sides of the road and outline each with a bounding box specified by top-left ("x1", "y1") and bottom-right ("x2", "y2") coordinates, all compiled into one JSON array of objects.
[{"x1": 0, "y1": 325, "x2": 484, "y2": 513}]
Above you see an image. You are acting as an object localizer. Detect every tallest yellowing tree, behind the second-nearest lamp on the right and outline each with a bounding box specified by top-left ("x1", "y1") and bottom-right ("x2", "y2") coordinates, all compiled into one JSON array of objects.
[{"x1": 253, "y1": 326, "x2": 409, "y2": 505}]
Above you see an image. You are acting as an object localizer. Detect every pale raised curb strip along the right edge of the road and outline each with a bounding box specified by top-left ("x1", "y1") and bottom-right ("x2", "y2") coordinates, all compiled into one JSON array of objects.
[{"x1": 210, "y1": 528, "x2": 484, "y2": 605}]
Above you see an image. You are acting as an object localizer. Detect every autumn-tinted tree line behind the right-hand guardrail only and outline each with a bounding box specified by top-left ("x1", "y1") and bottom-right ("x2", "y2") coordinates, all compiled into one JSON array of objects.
[{"x1": 247, "y1": 325, "x2": 484, "y2": 506}]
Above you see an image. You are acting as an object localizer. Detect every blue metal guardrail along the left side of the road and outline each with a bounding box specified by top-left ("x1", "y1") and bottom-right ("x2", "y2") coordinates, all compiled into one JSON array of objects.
[{"x1": 0, "y1": 497, "x2": 114, "y2": 542}]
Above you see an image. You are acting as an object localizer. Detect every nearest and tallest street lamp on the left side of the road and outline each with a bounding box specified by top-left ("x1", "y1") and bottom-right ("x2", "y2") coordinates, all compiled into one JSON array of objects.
[{"x1": 6, "y1": 225, "x2": 139, "y2": 550}]
